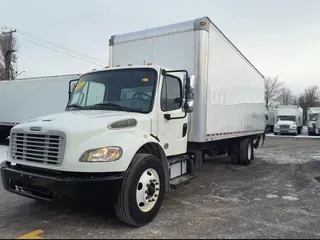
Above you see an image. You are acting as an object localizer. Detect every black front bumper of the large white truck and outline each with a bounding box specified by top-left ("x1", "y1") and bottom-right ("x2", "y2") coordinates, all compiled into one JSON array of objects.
[{"x1": 1, "y1": 161, "x2": 123, "y2": 201}]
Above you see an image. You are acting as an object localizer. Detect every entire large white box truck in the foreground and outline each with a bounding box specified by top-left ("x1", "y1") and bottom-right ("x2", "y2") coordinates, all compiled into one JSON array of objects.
[{"x1": 1, "y1": 17, "x2": 265, "y2": 226}]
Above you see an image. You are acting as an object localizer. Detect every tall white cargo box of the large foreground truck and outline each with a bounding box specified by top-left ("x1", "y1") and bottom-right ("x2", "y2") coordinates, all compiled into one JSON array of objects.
[{"x1": 109, "y1": 17, "x2": 265, "y2": 142}]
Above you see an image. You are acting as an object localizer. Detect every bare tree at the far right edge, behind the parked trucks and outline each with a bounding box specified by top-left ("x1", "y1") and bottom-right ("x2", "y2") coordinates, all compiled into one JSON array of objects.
[{"x1": 298, "y1": 85, "x2": 320, "y2": 120}]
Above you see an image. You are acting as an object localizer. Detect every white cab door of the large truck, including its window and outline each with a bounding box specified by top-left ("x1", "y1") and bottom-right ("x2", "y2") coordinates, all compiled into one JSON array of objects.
[{"x1": 158, "y1": 73, "x2": 189, "y2": 156}]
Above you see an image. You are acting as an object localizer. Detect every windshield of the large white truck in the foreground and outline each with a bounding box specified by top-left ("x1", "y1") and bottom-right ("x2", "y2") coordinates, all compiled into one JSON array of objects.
[{"x1": 67, "y1": 68, "x2": 157, "y2": 113}]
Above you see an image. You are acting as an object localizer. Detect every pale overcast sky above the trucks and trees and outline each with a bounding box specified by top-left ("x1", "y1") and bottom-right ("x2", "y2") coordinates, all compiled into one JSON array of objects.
[{"x1": 0, "y1": 0, "x2": 320, "y2": 93}]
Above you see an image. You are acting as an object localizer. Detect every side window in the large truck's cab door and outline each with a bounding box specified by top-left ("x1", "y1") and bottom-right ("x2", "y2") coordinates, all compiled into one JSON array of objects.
[{"x1": 161, "y1": 76, "x2": 182, "y2": 112}]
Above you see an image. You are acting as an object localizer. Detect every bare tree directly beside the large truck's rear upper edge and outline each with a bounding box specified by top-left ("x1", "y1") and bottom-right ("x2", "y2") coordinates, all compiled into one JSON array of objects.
[{"x1": 264, "y1": 77, "x2": 283, "y2": 108}]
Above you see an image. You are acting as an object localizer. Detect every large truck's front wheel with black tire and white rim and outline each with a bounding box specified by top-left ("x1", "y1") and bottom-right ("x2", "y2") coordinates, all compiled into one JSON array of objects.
[{"x1": 115, "y1": 154, "x2": 165, "y2": 227}]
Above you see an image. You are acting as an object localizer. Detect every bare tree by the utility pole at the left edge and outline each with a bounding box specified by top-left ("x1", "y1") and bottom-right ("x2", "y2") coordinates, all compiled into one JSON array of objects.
[{"x1": 0, "y1": 31, "x2": 18, "y2": 81}]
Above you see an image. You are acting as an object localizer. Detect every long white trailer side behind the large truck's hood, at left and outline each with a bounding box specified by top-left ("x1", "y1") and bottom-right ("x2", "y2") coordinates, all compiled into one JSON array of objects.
[{"x1": 0, "y1": 74, "x2": 80, "y2": 141}]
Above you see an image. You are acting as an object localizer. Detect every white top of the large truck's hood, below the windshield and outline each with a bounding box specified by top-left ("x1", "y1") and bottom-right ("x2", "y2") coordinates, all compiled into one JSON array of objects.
[{"x1": 14, "y1": 110, "x2": 151, "y2": 135}]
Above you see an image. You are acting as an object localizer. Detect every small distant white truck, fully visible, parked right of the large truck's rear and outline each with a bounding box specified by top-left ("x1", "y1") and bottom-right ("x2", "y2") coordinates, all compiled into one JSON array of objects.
[{"x1": 273, "y1": 105, "x2": 303, "y2": 135}]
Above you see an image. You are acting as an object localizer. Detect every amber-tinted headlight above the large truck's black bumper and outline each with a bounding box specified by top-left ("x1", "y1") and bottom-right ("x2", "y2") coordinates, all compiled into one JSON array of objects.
[{"x1": 79, "y1": 147, "x2": 122, "y2": 162}]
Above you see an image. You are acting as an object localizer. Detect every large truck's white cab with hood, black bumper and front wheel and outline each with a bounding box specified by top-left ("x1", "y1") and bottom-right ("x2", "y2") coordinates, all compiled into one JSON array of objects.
[{"x1": 1, "y1": 65, "x2": 193, "y2": 226}]
